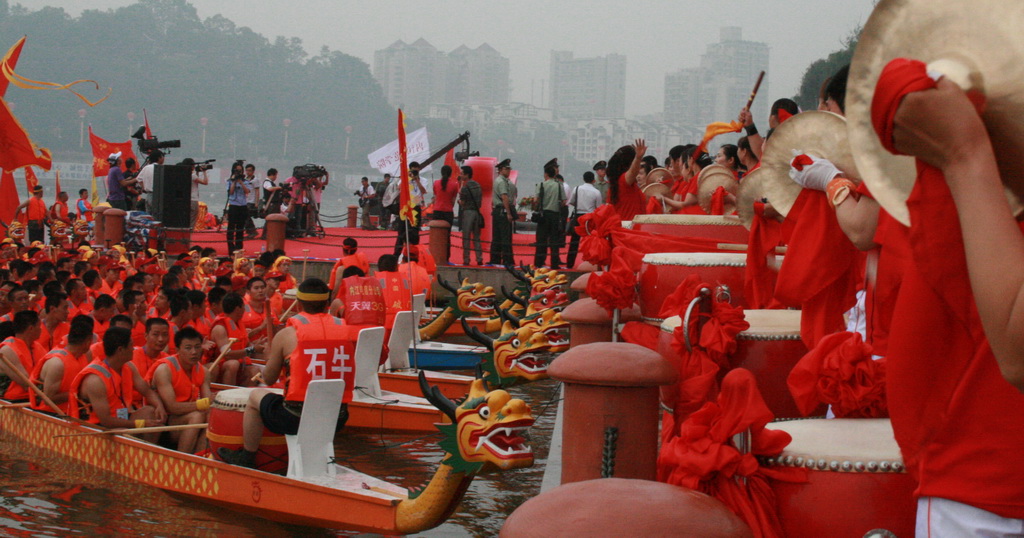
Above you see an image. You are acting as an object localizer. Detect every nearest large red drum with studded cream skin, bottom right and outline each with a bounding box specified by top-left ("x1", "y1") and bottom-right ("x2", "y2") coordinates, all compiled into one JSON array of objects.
[{"x1": 761, "y1": 418, "x2": 917, "y2": 538}]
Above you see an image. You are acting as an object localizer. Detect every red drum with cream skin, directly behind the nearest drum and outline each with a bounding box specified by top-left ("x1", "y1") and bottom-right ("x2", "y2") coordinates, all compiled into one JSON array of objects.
[{"x1": 657, "y1": 309, "x2": 825, "y2": 418}]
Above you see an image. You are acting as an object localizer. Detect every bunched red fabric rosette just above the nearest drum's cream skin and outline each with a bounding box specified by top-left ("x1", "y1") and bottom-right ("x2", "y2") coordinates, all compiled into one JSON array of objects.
[{"x1": 786, "y1": 332, "x2": 889, "y2": 418}]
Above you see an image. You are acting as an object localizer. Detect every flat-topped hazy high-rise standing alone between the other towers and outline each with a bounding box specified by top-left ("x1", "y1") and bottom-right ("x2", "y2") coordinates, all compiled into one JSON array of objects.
[{"x1": 550, "y1": 50, "x2": 626, "y2": 118}]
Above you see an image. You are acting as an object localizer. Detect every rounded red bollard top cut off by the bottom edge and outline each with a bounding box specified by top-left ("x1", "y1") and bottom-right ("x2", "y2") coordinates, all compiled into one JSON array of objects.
[{"x1": 499, "y1": 479, "x2": 753, "y2": 538}]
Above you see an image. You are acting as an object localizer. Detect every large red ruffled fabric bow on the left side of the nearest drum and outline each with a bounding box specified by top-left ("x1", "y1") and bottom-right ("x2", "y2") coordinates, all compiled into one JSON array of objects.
[{"x1": 657, "y1": 368, "x2": 807, "y2": 537}]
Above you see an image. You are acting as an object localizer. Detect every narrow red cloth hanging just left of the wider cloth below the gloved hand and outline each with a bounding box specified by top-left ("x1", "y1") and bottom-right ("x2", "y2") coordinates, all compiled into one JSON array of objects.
[{"x1": 743, "y1": 202, "x2": 782, "y2": 309}]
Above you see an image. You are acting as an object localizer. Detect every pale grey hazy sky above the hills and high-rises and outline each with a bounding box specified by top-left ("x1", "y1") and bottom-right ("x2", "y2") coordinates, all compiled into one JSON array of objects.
[{"x1": 22, "y1": 0, "x2": 874, "y2": 116}]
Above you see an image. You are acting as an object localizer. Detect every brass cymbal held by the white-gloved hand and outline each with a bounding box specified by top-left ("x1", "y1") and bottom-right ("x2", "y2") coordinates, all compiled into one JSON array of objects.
[{"x1": 760, "y1": 111, "x2": 860, "y2": 216}]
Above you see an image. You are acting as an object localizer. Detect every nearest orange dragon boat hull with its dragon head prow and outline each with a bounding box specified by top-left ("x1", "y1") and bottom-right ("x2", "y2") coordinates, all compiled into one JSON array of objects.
[{"x1": 0, "y1": 377, "x2": 534, "y2": 535}]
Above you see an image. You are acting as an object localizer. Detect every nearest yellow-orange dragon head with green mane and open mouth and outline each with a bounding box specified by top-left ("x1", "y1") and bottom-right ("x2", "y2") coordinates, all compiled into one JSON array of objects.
[{"x1": 420, "y1": 373, "x2": 534, "y2": 474}]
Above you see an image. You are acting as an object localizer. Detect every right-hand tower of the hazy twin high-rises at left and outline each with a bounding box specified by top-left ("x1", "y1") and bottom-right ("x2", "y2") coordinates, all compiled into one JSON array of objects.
[{"x1": 444, "y1": 43, "x2": 509, "y2": 105}]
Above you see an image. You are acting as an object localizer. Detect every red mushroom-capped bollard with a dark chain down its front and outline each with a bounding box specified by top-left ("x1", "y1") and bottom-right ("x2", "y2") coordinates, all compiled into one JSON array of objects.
[{"x1": 548, "y1": 342, "x2": 679, "y2": 484}]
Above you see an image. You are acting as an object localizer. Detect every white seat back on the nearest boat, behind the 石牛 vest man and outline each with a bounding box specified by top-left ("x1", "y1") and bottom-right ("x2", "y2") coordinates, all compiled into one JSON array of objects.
[{"x1": 285, "y1": 379, "x2": 345, "y2": 479}]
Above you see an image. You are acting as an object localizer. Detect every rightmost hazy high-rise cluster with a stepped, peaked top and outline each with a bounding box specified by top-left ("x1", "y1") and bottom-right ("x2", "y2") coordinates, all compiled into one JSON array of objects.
[{"x1": 665, "y1": 27, "x2": 770, "y2": 129}]
